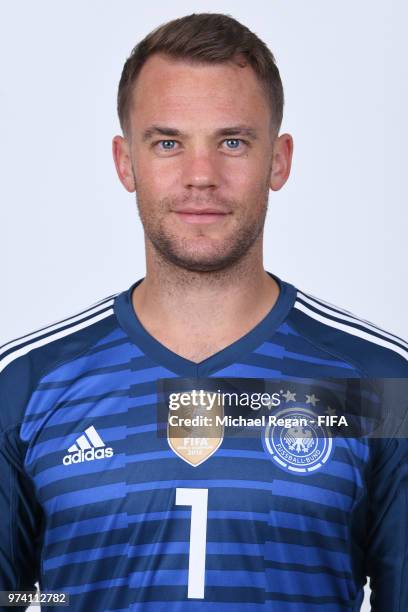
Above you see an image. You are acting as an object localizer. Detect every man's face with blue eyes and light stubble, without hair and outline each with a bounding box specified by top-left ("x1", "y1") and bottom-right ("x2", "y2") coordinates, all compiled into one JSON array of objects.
[{"x1": 113, "y1": 55, "x2": 288, "y2": 271}]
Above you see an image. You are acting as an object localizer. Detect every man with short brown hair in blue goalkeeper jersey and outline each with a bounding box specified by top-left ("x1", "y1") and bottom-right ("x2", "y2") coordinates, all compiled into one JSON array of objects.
[{"x1": 0, "y1": 14, "x2": 408, "y2": 612}]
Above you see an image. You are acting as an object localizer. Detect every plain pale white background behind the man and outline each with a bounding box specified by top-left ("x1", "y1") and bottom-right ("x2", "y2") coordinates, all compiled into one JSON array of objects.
[{"x1": 0, "y1": 0, "x2": 408, "y2": 609}]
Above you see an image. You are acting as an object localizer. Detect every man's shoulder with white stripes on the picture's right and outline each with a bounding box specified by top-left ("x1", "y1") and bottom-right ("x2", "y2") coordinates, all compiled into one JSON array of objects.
[{"x1": 290, "y1": 289, "x2": 408, "y2": 378}]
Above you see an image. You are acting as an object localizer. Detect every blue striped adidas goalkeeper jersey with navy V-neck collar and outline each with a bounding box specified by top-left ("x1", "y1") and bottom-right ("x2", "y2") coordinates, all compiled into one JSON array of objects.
[{"x1": 0, "y1": 273, "x2": 408, "y2": 612}]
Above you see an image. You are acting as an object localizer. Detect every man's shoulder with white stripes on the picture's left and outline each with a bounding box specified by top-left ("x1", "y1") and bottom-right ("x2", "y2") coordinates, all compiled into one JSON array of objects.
[{"x1": 0, "y1": 295, "x2": 115, "y2": 431}]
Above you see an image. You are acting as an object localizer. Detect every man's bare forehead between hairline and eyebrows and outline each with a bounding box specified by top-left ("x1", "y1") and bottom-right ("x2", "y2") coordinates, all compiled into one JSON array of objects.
[{"x1": 131, "y1": 54, "x2": 269, "y2": 128}]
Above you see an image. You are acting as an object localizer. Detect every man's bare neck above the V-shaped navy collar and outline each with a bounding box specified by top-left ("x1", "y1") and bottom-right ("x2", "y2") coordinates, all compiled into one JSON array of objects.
[{"x1": 132, "y1": 235, "x2": 279, "y2": 358}]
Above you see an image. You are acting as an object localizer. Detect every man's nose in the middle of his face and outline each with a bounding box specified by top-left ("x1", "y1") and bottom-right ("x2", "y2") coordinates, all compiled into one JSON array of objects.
[{"x1": 183, "y1": 149, "x2": 220, "y2": 189}]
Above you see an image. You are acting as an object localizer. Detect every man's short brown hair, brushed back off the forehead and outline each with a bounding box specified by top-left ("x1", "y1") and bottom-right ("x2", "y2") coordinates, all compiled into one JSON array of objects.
[{"x1": 117, "y1": 13, "x2": 284, "y2": 135}]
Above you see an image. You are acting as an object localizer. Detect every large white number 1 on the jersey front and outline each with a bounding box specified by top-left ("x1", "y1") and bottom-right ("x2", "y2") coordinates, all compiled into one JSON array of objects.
[{"x1": 176, "y1": 489, "x2": 208, "y2": 599}]
